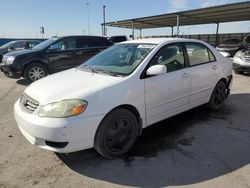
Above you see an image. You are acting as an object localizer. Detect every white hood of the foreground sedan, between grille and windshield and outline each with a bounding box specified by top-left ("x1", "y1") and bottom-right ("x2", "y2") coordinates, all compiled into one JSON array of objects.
[{"x1": 24, "y1": 68, "x2": 123, "y2": 105}]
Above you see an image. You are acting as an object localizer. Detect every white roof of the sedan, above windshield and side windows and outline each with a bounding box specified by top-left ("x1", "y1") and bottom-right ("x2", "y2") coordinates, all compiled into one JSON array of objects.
[{"x1": 122, "y1": 38, "x2": 206, "y2": 44}]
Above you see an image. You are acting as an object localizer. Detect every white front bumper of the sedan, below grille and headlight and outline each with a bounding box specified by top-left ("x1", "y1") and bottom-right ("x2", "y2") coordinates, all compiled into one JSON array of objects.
[{"x1": 14, "y1": 100, "x2": 104, "y2": 153}]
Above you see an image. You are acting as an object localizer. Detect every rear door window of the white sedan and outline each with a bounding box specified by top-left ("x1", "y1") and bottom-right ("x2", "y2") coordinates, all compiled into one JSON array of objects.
[{"x1": 185, "y1": 43, "x2": 215, "y2": 66}]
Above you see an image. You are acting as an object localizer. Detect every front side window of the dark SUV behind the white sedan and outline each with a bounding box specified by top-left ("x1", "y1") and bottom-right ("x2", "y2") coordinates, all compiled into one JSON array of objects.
[{"x1": 49, "y1": 38, "x2": 76, "y2": 51}]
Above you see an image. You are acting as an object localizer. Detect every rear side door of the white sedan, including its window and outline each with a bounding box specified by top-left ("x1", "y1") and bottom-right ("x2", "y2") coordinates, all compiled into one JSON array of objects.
[{"x1": 185, "y1": 42, "x2": 219, "y2": 107}]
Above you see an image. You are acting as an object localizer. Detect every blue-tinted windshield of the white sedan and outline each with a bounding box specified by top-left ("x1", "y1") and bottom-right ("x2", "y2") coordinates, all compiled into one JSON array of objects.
[{"x1": 79, "y1": 43, "x2": 156, "y2": 76}]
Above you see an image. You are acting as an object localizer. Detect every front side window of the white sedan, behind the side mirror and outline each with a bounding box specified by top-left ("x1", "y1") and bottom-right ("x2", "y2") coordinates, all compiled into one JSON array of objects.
[{"x1": 147, "y1": 44, "x2": 185, "y2": 72}]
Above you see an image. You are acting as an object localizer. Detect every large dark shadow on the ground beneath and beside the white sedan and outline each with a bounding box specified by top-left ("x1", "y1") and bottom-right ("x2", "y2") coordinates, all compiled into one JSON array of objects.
[{"x1": 57, "y1": 94, "x2": 250, "y2": 187}]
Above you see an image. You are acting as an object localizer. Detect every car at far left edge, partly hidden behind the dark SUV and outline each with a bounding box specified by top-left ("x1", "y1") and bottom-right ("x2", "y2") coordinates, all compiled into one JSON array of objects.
[{"x1": 0, "y1": 40, "x2": 41, "y2": 63}]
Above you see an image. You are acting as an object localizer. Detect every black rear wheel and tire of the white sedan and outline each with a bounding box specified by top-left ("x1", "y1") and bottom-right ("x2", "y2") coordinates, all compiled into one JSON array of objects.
[{"x1": 208, "y1": 81, "x2": 227, "y2": 110}]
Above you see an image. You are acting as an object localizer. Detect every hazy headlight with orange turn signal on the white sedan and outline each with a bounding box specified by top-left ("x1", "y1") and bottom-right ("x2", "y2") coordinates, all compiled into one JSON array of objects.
[{"x1": 38, "y1": 99, "x2": 88, "y2": 118}]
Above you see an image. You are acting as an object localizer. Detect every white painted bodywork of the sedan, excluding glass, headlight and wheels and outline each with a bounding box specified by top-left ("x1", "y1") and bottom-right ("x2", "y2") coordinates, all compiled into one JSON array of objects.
[{"x1": 14, "y1": 38, "x2": 232, "y2": 152}]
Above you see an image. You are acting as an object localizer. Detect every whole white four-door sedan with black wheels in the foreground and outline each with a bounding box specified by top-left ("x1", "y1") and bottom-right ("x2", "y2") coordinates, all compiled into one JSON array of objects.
[{"x1": 14, "y1": 38, "x2": 232, "y2": 158}]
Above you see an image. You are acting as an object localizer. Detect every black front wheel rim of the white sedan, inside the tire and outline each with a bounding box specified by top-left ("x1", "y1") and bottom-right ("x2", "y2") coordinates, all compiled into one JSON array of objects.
[{"x1": 106, "y1": 117, "x2": 135, "y2": 153}]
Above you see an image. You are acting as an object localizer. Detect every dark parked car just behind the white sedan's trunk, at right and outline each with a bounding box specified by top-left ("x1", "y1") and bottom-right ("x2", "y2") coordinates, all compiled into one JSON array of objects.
[{"x1": 216, "y1": 39, "x2": 243, "y2": 57}]
